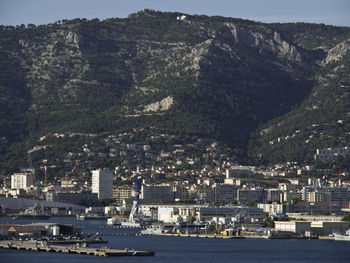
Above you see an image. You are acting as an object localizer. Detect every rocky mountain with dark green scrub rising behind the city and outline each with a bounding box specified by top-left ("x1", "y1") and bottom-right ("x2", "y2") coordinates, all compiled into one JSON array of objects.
[{"x1": 0, "y1": 10, "x2": 350, "y2": 172}]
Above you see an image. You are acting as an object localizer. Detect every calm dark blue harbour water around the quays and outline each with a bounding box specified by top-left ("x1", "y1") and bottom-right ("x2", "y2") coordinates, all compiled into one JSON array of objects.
[{"x1": 0, "y1": 218, "x2": 350, "y2": 263}]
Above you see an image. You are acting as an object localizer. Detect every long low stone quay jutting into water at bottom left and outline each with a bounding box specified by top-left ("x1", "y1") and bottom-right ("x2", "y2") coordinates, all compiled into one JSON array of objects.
[{"x1": 0, "y1": 240, "x2": 155, "y2": 257}]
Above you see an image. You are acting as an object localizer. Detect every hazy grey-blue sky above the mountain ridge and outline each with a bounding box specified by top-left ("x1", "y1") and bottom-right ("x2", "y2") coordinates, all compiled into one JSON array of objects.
[{"x1": 0, "y1": 0, "x2": 350, "y2": 26}]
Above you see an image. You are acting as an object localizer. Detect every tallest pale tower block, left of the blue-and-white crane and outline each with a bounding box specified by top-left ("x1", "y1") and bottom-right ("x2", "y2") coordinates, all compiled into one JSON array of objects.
[{"x1": 91, "y1": 169, "x2": 113, "y2": 200}]
